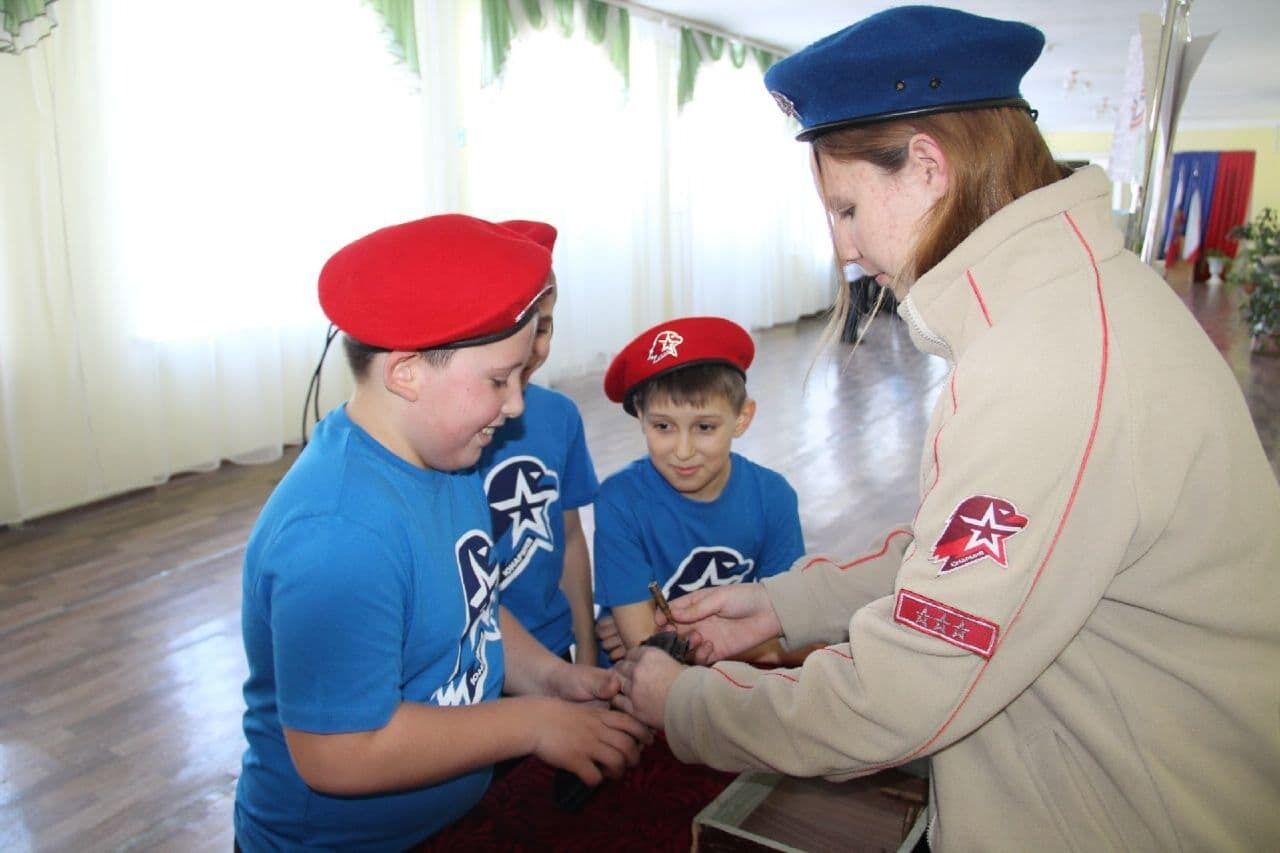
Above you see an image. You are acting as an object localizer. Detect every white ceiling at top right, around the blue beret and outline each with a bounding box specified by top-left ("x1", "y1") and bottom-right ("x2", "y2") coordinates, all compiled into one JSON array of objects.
[{"x1": 630, "y1": 0, "x2": 1280, "y2": 131}]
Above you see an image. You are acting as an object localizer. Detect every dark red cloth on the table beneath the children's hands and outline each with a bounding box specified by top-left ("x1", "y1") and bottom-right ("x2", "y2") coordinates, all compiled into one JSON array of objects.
[{"x1": 417, "y1": 734, "x2": 736, "y2": 853}]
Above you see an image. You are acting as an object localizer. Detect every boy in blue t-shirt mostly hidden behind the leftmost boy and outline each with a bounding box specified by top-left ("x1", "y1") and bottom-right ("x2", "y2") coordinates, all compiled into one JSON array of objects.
[{"x1": 480, "y1": 219, "x2": 599, "y2": 666}]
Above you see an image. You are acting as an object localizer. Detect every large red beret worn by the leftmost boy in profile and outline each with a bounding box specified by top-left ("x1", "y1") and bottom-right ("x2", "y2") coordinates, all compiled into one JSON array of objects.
[{"x1": 320, "y1": 214, "x2": 552, "y2": 350}]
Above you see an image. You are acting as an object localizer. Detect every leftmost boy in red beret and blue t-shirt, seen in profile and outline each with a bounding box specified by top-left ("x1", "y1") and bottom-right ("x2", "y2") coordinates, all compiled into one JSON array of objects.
[{"x1": 236, "y1": 214, "x2": 649, "y2": 850}]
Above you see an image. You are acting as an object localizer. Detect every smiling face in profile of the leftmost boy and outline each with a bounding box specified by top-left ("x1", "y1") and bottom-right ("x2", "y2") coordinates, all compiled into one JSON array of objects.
[{"x1": 412, "y1": 323, "x2": 534, "y2": 471}]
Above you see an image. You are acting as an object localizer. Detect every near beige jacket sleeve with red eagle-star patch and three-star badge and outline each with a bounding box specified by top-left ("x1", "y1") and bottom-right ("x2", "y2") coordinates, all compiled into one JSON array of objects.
[{"x1": 666, "y1": 297, "x2": 1137, "y2": 779}]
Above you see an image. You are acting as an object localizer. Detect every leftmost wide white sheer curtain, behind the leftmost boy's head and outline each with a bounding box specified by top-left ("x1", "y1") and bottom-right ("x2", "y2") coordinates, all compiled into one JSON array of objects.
[{"x1": 0, "y1": 0, "x2": 435, "y2": 523}]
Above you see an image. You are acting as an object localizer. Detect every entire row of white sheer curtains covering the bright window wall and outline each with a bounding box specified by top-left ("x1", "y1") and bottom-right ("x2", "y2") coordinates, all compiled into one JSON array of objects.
[{"x1": 0, "y1": 0, "x2": 832, "y2": 524}]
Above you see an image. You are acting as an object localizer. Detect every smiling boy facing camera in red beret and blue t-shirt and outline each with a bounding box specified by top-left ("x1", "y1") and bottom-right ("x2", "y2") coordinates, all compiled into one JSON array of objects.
[{"x1": 595, "y1": 316, "x2": 804, "y2": 662}]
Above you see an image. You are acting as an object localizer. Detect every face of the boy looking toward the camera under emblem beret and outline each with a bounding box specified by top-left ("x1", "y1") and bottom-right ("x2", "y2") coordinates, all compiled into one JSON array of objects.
[{"x1": 640, "y1": 396, "x2": 755, "y2": 501}]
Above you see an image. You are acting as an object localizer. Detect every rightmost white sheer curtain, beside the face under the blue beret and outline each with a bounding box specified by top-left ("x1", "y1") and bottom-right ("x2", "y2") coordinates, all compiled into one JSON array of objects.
[{"x1": 671, "y1": 59, "x2": 835, "y2": 328}]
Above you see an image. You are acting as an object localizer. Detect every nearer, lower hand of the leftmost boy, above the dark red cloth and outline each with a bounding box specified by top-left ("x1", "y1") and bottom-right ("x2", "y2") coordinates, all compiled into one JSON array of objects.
[{"x1": 534, "y1": 696, "x2": 653, "y2": 785}]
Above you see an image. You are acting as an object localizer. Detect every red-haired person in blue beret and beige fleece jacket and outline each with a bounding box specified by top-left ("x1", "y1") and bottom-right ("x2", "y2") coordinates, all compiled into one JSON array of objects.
[{"x1": 618, "y1": 6, "x2": 1280, "y2": 853}]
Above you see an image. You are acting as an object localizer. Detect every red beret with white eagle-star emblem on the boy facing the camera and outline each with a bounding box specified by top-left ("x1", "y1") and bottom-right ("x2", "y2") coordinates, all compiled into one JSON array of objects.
[{"x1": 604, "y1": 316, "x2": 755, "y2": 415}]
